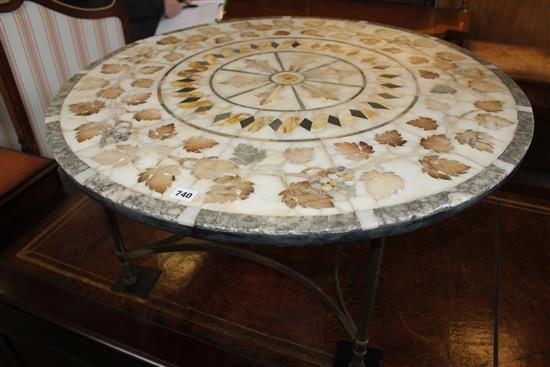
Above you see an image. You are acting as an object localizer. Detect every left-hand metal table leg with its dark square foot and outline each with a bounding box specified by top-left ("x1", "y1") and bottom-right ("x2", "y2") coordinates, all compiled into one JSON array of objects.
[{"x1": 105, "y1": 208, "x2": 160, "y2": 298}]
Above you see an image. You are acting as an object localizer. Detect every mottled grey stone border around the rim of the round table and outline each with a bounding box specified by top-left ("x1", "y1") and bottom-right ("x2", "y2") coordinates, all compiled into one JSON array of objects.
[{"x1": 46, "y1": 16, "x2": 534, "y2": 246}]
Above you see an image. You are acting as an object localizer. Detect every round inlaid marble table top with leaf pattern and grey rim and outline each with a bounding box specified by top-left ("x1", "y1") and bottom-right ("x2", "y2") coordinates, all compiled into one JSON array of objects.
[{"x1": 46, "y1": 17, "x2": 533, "y2": 244}]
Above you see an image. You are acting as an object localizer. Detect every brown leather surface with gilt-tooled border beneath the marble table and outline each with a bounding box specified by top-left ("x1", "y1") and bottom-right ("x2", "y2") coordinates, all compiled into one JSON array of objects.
[{"x1": 0, "y1": 188, "x2": 550, "y2": 367}]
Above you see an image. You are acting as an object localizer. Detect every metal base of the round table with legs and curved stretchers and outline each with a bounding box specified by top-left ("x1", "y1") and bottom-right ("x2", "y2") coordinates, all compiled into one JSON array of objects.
[{"x1": 105, "y1": 209, "x2": 385, "y2": 367}]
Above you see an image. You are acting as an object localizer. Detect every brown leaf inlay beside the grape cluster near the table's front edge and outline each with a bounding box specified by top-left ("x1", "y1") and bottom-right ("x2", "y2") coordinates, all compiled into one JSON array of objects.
[{"x1": 279, "y1": 181, "x2": 334, "y2": 209}]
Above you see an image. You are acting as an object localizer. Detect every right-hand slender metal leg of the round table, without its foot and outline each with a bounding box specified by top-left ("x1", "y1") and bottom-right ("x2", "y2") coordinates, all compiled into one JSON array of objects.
[{"x1": 350, "y1": 238, "x2": 385, "y2": 367}]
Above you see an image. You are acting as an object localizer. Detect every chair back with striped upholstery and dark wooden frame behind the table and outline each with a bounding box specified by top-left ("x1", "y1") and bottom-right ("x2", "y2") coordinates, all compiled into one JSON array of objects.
[{"x1": 0, "y1": 0, "x2": 129, "y2": 156}]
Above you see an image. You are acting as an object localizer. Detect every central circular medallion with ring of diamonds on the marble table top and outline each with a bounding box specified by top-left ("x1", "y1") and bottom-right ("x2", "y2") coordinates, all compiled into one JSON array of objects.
[{"x1": 159, "y1": 39, "x2": 418, "y2": 141}]
